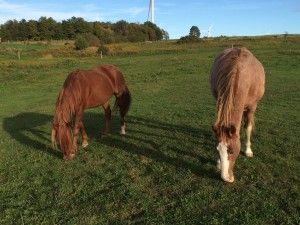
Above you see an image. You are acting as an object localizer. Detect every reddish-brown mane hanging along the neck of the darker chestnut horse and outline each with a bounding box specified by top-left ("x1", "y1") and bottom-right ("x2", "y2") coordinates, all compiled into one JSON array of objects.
[{"x1": 52, "y1": 70, "x2": 82, "y2": 149}]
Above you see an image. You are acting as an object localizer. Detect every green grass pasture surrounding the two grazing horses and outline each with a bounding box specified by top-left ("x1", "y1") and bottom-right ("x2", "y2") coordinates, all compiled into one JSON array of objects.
[{"x1": 0, "y1": 37, "x2": 300, "y2": 225}]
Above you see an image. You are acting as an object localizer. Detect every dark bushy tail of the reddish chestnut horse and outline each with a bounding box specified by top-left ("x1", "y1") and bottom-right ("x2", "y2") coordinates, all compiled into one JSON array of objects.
[{"x1": 113, "y1": 85, "x2": 131, "y2": 116}]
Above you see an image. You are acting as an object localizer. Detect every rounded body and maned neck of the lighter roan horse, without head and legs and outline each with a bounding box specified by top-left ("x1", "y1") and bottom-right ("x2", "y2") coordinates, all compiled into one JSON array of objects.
[{"x1": 210, "y1": 48, "x2": 264, "y2": 127}]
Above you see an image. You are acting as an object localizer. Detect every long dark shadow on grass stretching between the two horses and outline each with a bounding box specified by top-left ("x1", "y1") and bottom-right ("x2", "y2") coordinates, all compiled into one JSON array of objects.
[{"x1": 84, "y1": 113, "x2": 219, "y2": 180}]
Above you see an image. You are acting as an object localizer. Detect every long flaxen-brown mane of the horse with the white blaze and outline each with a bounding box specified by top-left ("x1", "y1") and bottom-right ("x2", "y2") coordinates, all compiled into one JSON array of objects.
[{"x1": 215, "y1": 48, "x2": 242, "y2": 127}]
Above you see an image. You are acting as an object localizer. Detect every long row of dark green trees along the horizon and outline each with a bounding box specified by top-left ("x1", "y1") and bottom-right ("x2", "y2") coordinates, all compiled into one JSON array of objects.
[{"x1": 0, "y1": 17, "x2": 169, "y2": 44}]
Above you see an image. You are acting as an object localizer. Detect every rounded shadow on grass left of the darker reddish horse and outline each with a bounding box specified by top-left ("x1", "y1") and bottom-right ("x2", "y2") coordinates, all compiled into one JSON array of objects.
[{"x1": 3, "y1": 112, "x2": 61, "y2": 158}]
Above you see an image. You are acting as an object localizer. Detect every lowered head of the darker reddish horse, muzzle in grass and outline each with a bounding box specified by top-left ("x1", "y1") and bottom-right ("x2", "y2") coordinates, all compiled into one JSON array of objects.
[{"x1": 52, "y1": 123, "x2": 76, "y2": 160}]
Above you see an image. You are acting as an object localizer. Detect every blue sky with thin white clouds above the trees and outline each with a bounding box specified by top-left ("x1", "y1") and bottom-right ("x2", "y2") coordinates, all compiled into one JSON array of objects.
[{"x1": 0, "y1": 0, "x2": 300, "y2": 39}]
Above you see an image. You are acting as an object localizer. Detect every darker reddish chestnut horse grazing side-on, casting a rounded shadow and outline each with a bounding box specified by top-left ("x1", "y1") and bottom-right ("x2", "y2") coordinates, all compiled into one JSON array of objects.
[{"x1": 52, "y1": 65, "x2": 131, "y2": 160}]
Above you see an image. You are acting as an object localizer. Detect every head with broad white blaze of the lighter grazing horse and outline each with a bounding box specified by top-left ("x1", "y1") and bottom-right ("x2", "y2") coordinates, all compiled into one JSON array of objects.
[{"x1": 212, "y1": 125, "x2": 241, "y2": 183}]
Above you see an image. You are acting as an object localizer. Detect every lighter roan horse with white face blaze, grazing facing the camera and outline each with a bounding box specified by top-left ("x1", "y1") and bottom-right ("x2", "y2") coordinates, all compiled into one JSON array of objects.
[{"x1": 210, "y1": 48, "x2": 265, "y2": 182}]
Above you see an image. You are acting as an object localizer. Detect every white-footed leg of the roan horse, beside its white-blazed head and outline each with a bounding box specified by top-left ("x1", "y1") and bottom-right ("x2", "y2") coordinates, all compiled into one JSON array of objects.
[{"x1": 244, "y1": 109, "x2": 255, "y2": 157}]
